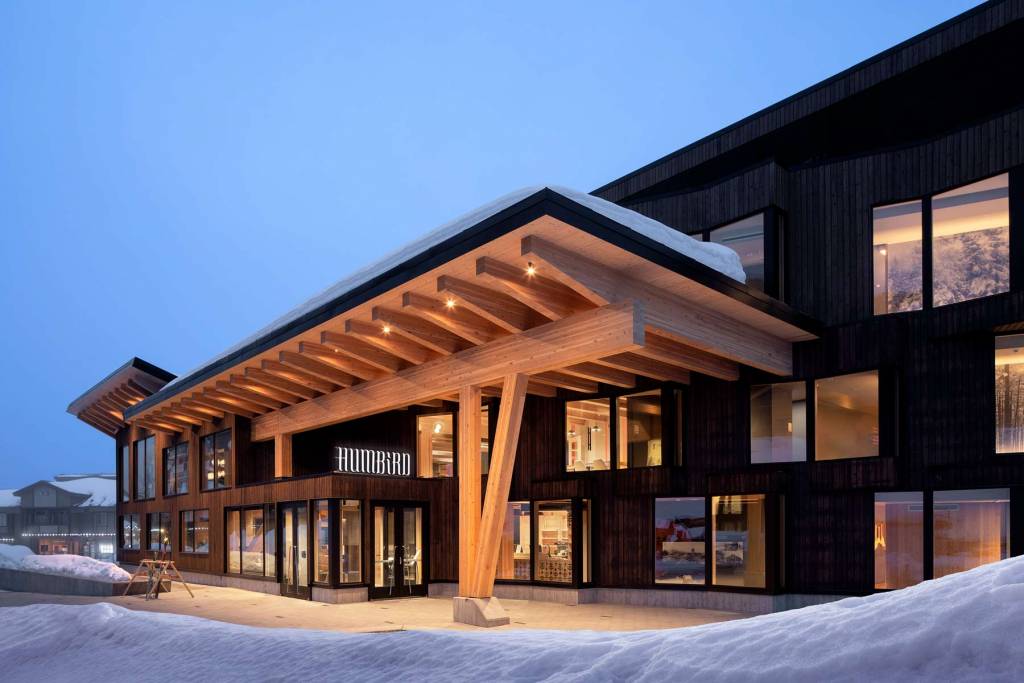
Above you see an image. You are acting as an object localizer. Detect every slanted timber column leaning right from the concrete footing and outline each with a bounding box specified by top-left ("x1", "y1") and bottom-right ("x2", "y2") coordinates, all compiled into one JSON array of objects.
[{"x1": 472, "y1": 375, "x2": 527, "y2": 598}]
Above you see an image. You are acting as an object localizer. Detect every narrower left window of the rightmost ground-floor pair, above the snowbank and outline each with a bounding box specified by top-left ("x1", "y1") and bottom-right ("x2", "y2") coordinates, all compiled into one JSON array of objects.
[{"x1": 874, "y1": 492, "x2": 925, "y2": 589}]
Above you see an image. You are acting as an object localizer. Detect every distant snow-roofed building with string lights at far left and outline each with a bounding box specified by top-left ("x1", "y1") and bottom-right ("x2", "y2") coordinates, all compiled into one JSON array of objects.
[{"x1": 0, "y1": 474, "x2": 117, "y2": 560}]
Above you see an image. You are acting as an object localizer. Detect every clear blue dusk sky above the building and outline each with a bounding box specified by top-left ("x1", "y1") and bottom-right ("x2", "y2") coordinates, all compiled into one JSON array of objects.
[{"x1": 0, "y1": 0, "x2": 977, "y2": 487}]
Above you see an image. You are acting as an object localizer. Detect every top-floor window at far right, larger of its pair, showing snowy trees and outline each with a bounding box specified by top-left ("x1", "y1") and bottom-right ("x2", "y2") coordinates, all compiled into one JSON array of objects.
[{"x1": 932, "y1": 173, "x2": 1010, "y2": 306}]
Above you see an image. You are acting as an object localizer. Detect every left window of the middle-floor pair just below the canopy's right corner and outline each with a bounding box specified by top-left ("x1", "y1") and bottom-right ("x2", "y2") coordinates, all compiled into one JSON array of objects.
[{"x1": 751, "y1": 382, "x2": 807, "y2": 464}]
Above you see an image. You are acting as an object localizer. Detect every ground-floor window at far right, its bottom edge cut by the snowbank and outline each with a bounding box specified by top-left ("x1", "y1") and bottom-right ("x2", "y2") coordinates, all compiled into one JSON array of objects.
[{"x1": 932, "y1": 488, "x2": 1010, "y2": 579}]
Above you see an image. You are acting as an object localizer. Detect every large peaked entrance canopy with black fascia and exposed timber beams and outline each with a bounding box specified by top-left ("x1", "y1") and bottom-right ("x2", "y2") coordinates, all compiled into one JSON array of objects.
[{"x1": 114, "y1": 188, "x2": 818, "y2": 440}]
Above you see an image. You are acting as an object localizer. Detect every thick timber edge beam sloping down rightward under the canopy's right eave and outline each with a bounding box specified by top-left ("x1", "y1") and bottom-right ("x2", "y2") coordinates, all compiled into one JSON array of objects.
[{"x1": 520, "y1": 236, "x2": 793, "y2": 375}]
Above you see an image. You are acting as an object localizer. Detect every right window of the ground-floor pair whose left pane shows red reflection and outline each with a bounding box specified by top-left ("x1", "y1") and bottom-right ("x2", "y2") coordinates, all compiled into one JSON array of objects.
[{"x1": 711, "y1": 495, "x2": 766, "y2": 588}]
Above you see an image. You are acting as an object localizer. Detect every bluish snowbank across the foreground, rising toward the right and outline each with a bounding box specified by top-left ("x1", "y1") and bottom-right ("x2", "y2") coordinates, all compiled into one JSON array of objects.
[{"x1": 0, "y1": 557, "x2": 1024, "y2": 683}]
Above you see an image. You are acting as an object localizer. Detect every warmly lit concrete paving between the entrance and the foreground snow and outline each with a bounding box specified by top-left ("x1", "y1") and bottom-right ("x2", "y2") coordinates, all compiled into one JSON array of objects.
[{"x1": 0, "y1": 585, "x2": 745, "y2": 633}]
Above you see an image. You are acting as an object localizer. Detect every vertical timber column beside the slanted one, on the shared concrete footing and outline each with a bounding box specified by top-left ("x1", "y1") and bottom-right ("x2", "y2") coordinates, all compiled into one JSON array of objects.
[{"x1": 458, "y1": 386, "x2": 480, "y2": 596}]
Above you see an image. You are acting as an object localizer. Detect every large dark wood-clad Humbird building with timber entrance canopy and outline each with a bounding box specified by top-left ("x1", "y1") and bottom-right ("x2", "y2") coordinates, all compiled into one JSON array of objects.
[{"x1": 70, "y1": 1, "x2": 1024, "y2": 621}]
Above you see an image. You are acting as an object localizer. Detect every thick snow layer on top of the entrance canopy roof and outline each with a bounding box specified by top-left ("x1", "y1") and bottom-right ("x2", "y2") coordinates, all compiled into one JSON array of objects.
[{"x1": 158, "y1": 185, "x2": 746, "y2": 394}]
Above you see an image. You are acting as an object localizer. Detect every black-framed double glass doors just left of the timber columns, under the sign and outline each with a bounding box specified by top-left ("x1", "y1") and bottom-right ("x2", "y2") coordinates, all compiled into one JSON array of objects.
[{"x1": 370, "y1": 503, "x2": 427, "y2": 598}]
